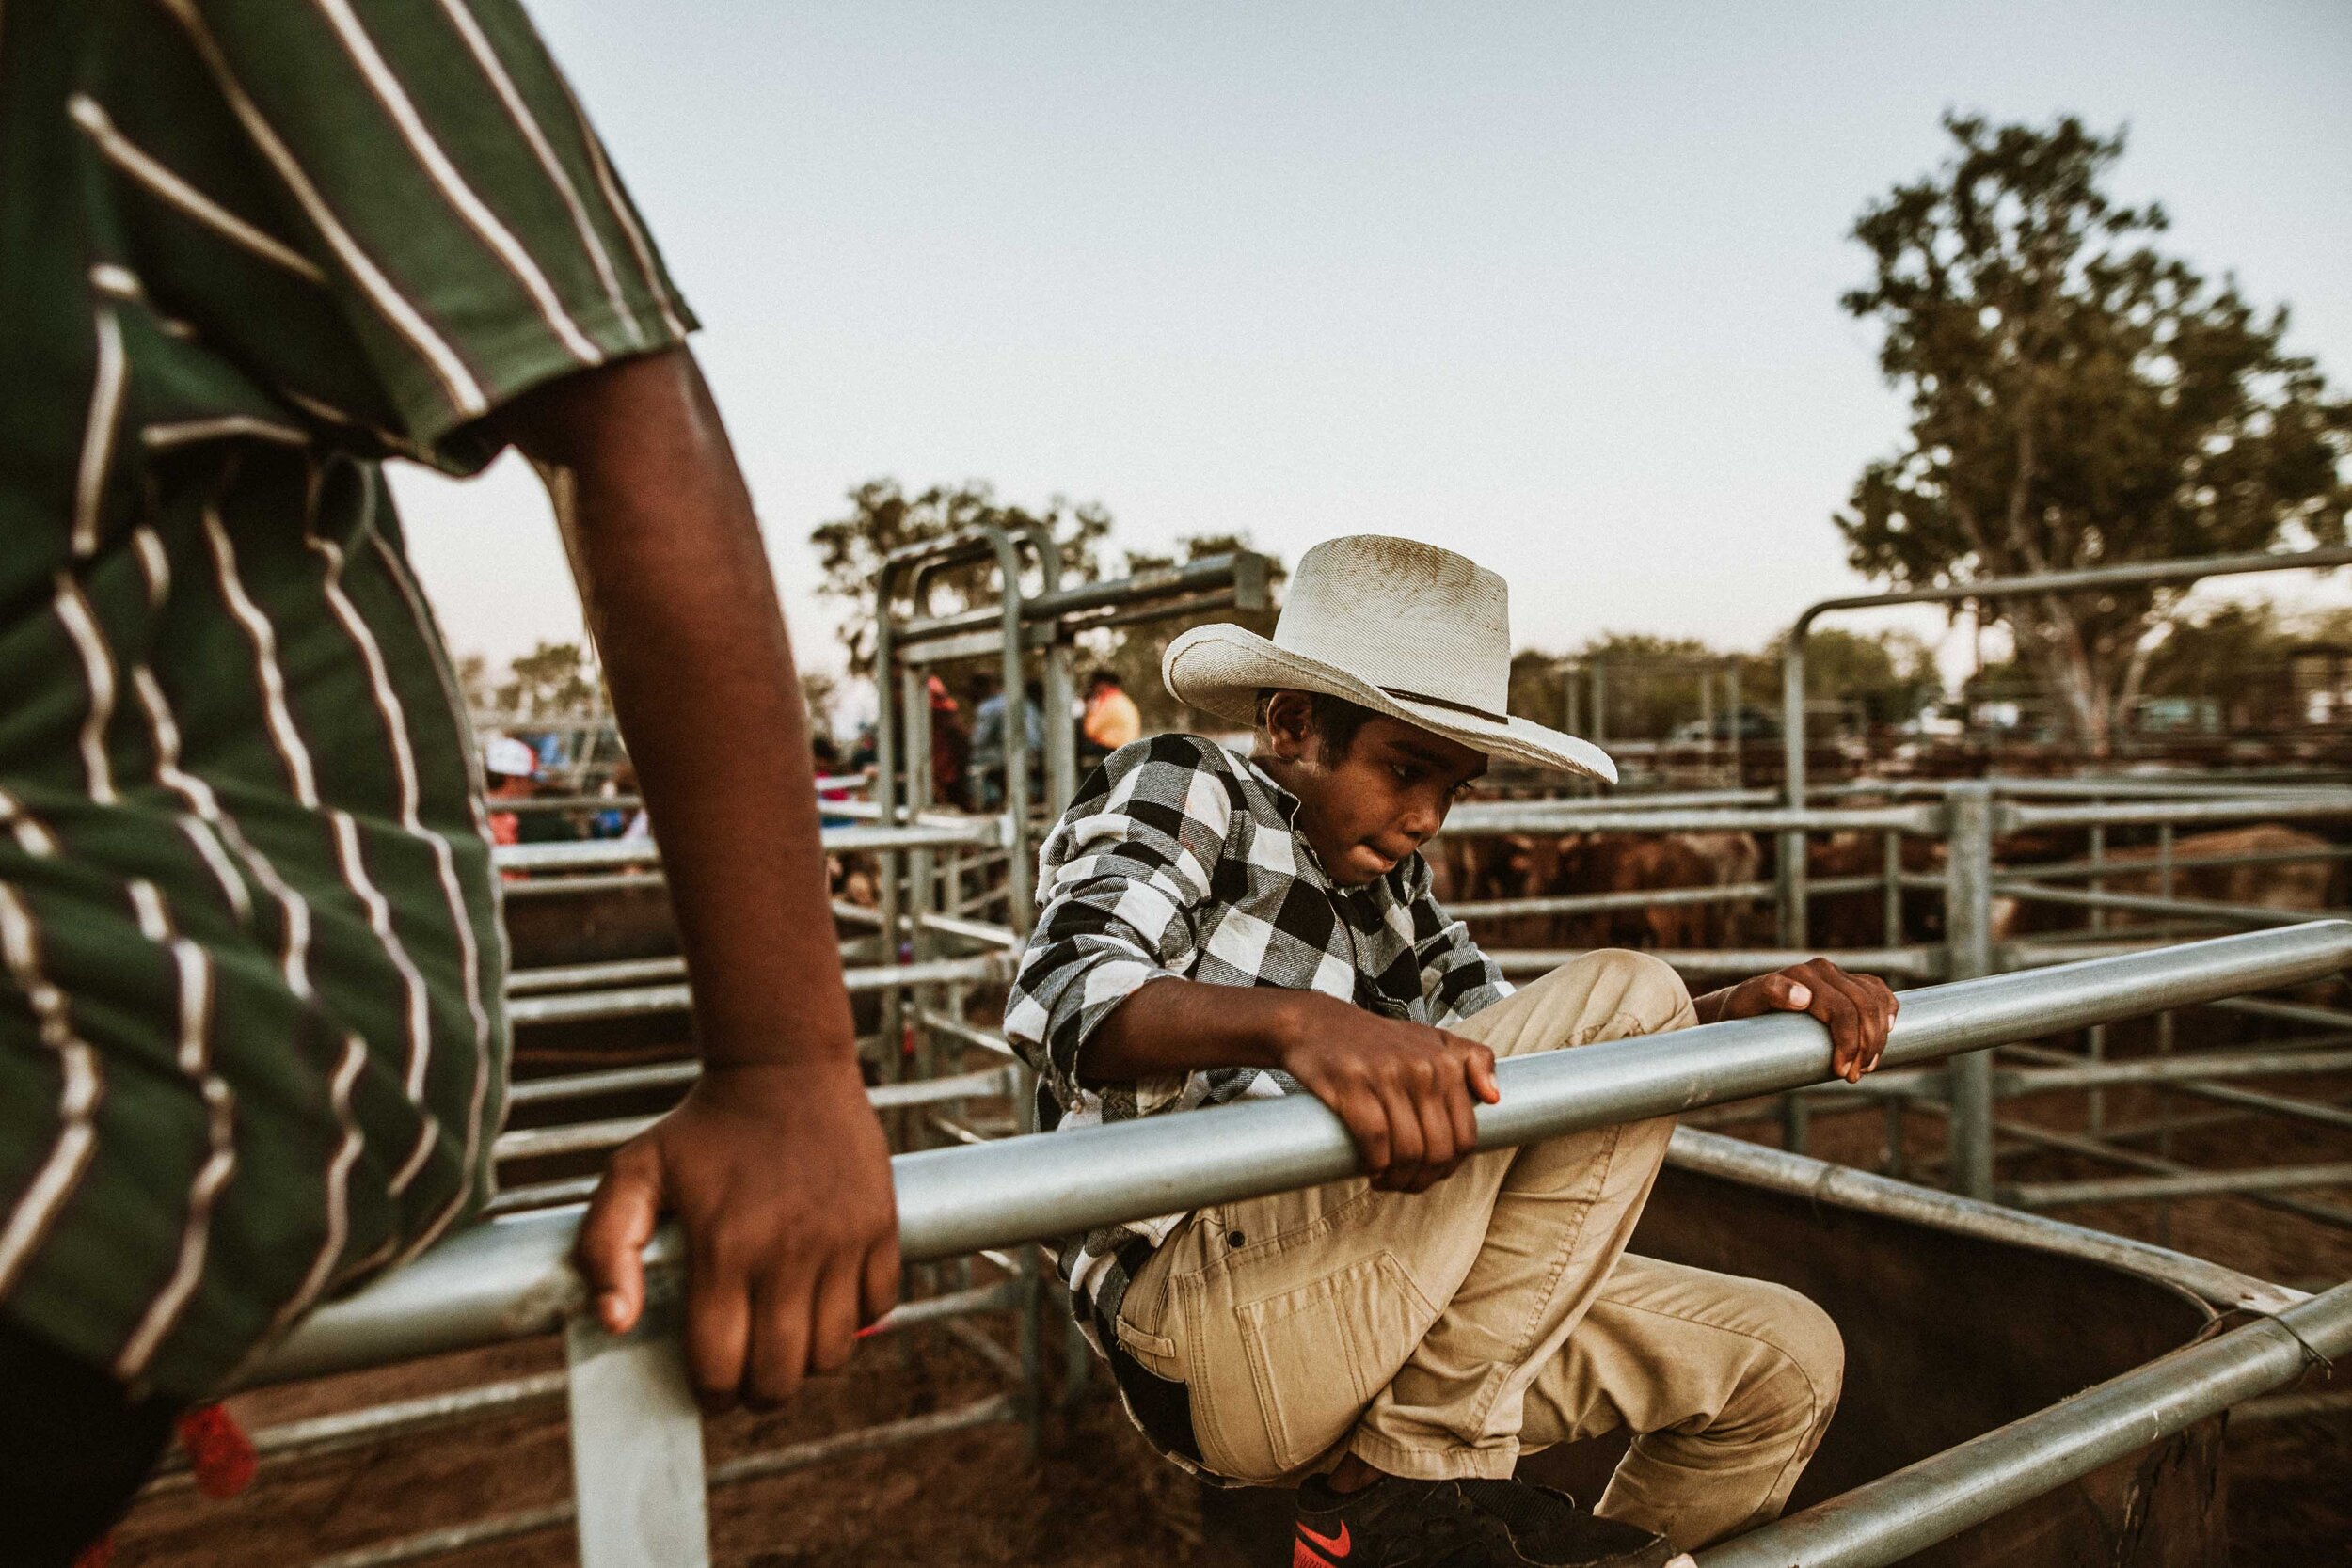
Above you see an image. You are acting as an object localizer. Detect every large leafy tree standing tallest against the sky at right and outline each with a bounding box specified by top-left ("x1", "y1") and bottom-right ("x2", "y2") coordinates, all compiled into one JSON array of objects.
[{"x1": 1837, "y1": 115, "x2": 2352, "y2": 754}]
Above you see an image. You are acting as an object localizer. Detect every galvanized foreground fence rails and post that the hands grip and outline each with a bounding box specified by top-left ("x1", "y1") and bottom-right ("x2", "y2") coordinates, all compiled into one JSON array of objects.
[{"x1": 212, "y1": 919, "x2": 2352, "y2": 1568}]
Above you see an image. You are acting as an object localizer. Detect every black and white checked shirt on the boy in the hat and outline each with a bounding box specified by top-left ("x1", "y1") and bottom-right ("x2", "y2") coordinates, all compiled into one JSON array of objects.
[{"x1": 1005, "y1": 734, "x2": 1510, "y2": 1350}]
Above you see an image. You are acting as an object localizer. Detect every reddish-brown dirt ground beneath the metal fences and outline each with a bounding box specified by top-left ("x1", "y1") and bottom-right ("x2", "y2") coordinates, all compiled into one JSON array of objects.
[{"x1": 116, "y1": 1053, "x2": 2352, "y2": 1568}]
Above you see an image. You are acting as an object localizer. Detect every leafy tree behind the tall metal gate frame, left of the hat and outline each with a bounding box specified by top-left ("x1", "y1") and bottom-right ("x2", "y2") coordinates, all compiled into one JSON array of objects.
[{"x1": 809, "y1": 480, "x2": 1110, "y2": 679}]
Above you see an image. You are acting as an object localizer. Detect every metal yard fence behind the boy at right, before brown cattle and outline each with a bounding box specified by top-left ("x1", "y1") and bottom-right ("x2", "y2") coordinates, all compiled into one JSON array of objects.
[{"x1": 1447, "y1": 778, "x2": 2352, "y2": 1225}]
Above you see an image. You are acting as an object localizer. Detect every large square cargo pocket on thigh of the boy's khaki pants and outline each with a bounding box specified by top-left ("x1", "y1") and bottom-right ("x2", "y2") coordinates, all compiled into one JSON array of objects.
[{"x1": 1240, "y1": 1253, "x2": 1438, "y2": 1477}]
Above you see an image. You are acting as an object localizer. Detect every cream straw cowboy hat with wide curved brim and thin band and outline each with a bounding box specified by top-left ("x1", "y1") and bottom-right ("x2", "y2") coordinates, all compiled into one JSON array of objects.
[{"x1": 1160, "y1": 533, "x2": 1616, "y2": 783}]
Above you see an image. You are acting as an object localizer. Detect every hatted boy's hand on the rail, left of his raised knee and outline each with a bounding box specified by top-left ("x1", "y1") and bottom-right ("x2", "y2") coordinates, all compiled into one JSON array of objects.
[{"x1": 1278, "y1": 992, "x2": 1501, "y2": 1192}]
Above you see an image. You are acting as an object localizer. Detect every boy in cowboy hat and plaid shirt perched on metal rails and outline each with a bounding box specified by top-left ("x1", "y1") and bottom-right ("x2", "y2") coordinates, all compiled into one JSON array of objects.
[{"x1": 1005, "y1": 536, "x2": 1896, "y2": 1568}]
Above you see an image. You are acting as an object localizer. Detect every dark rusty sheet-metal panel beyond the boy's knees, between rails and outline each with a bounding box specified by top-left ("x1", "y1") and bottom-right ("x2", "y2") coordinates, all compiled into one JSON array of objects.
[{"x1": 1209, "y1": 1168, "x2": 2228, "y2": 1568}]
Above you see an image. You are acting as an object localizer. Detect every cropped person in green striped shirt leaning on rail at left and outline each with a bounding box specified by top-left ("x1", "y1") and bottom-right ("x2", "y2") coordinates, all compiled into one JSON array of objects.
[{"x1": 0, "y1": 0, "x2": 898, "y2": 1568}]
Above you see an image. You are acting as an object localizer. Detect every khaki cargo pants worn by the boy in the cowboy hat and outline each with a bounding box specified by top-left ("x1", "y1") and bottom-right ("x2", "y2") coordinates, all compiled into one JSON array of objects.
[{"x1": 1120, "y1": 952, "x2": 1844, "y2": 1549}]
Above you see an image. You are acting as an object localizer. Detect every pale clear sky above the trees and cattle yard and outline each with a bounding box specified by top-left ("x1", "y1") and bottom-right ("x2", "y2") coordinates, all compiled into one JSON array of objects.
[{"x1": 395, "y1": 0, "x2": 2352, "y2": 705}]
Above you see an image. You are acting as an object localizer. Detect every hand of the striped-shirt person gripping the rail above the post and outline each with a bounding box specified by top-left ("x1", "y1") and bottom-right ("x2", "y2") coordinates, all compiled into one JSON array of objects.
[{"x1": 577, "y1": 1060, "x2": 898, "y2": 1408}]
